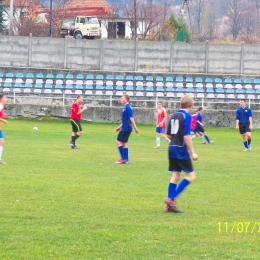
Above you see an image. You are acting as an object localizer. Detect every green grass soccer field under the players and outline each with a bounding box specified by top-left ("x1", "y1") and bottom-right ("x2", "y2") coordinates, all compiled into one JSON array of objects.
[{"x1": 0, "y1": 119, "x2": 260, "y2": 260}]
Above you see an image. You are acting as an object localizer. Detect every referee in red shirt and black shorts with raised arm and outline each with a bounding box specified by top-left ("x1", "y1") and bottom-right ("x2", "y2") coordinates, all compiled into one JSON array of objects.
[{"x1": 69, "y1": 96, "x2": 88, "y2": 149}]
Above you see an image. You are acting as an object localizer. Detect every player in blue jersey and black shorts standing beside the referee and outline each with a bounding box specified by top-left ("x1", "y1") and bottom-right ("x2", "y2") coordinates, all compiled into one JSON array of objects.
[{"x1": 115, "y1": 94, "x2": 139, "y2": 164}]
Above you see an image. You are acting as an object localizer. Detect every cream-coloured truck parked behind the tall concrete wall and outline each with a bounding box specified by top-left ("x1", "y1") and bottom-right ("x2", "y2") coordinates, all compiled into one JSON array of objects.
[{"x1": 60, "y1": 16, "x2": 101, "y2": 40}]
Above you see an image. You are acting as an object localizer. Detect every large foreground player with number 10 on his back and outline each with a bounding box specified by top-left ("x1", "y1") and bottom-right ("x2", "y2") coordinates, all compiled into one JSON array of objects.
[{"x1": 165, "y1": 95, "x2": 198, "y2": 213}]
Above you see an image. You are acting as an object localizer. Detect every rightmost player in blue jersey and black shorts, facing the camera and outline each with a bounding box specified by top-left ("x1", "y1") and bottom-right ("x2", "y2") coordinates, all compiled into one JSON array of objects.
[{"x1": 236, "y1": 99, "x2": 253, "y2": 152}]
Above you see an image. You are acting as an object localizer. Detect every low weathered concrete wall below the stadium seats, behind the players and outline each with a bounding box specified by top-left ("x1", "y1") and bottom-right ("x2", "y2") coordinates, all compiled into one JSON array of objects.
[{"x1": 3, "y1": 104, "x2": 260, "y2": 128}]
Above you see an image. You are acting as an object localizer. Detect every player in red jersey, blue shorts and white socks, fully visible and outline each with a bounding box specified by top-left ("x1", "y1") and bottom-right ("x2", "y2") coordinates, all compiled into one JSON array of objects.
[{"x1": 154, "y1": 101, "x2": 171, "y2": 148}]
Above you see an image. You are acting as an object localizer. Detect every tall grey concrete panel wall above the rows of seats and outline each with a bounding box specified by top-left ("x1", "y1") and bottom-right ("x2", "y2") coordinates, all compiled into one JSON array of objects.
[{"x1": 0, "y1": 36, "x2": 260, "y2": 75}]
